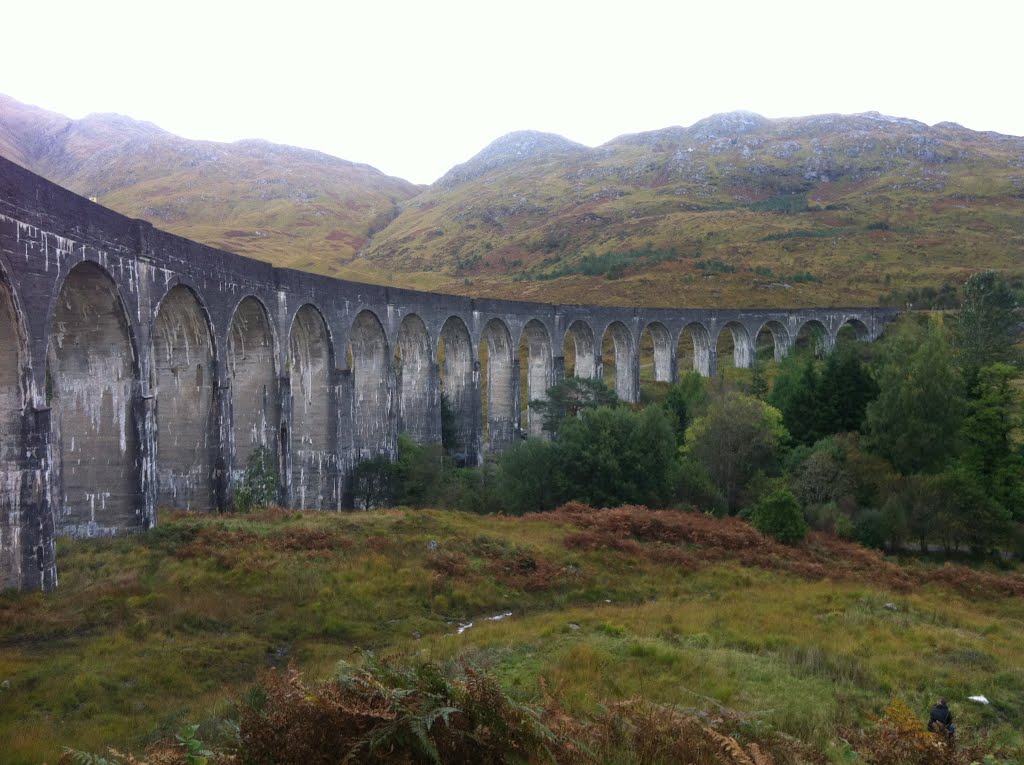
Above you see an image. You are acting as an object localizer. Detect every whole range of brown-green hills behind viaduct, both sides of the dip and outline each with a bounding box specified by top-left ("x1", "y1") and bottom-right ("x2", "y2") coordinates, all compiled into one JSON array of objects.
[{"x1": 0, "y1": 96, "x2": 1024, "y2": 307}]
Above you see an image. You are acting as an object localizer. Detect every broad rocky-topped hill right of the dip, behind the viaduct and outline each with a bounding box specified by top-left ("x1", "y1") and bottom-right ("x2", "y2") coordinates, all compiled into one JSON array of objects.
[{"x1": 365, "y1": 113, "x2": 1024, "y2": 305}]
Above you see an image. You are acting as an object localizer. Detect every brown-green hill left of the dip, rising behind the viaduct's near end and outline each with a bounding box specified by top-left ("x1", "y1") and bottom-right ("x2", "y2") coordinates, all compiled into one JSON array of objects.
[{"x1": 0, "y1": 95, "x2": 420, "y2": 274}]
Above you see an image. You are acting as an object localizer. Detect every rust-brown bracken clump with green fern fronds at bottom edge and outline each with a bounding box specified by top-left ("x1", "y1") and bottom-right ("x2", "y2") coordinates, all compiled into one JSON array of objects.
[{"x1": 239, "y1": 654, "x2": 565, "y2": 765}]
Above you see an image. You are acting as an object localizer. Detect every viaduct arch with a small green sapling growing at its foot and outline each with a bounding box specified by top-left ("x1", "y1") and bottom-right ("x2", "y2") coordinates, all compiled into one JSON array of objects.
[{"x1": 227, "y1": 296, "x2": 281, "y2": 486}]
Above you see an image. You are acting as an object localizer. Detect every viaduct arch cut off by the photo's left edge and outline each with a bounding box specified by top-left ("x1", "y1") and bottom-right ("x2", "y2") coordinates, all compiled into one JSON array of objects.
[{"x1": 0, "y1": 269, "x2": 29, "y2": 589}]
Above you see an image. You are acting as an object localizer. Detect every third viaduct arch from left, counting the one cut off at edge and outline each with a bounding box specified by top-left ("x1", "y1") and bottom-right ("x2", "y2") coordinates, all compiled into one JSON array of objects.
[{"x1": 153, "y1": 285, "x2": 219, "y2": 510}]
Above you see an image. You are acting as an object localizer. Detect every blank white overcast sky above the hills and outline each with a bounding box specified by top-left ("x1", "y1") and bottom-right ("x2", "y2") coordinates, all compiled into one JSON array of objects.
[{"x1": 0, "y1": 0, "x2": 1024, "y2": 182}]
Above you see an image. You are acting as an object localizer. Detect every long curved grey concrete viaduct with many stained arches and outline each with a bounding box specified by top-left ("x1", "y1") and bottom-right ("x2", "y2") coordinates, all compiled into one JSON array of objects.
[{"x1": 0, "y1": 159, "x2": 895, "y2": 589}]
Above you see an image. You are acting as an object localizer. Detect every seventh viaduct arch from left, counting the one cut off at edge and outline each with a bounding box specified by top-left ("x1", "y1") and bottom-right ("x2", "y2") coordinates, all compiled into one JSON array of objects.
[{"x1": 394, "y1": 313, "x2": 440, "y2": 443}]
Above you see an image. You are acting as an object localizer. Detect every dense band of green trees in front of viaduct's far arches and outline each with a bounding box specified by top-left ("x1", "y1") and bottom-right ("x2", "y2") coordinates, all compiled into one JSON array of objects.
[{"x1": 354, "y1": 271, "x2": 1024, "y2": 553}]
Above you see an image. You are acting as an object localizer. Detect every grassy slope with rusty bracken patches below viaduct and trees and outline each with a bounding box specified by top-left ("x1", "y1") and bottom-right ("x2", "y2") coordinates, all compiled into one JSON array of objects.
[{"x1": 0, "y1": 507, "x2": 1024, "y2": 764}]
